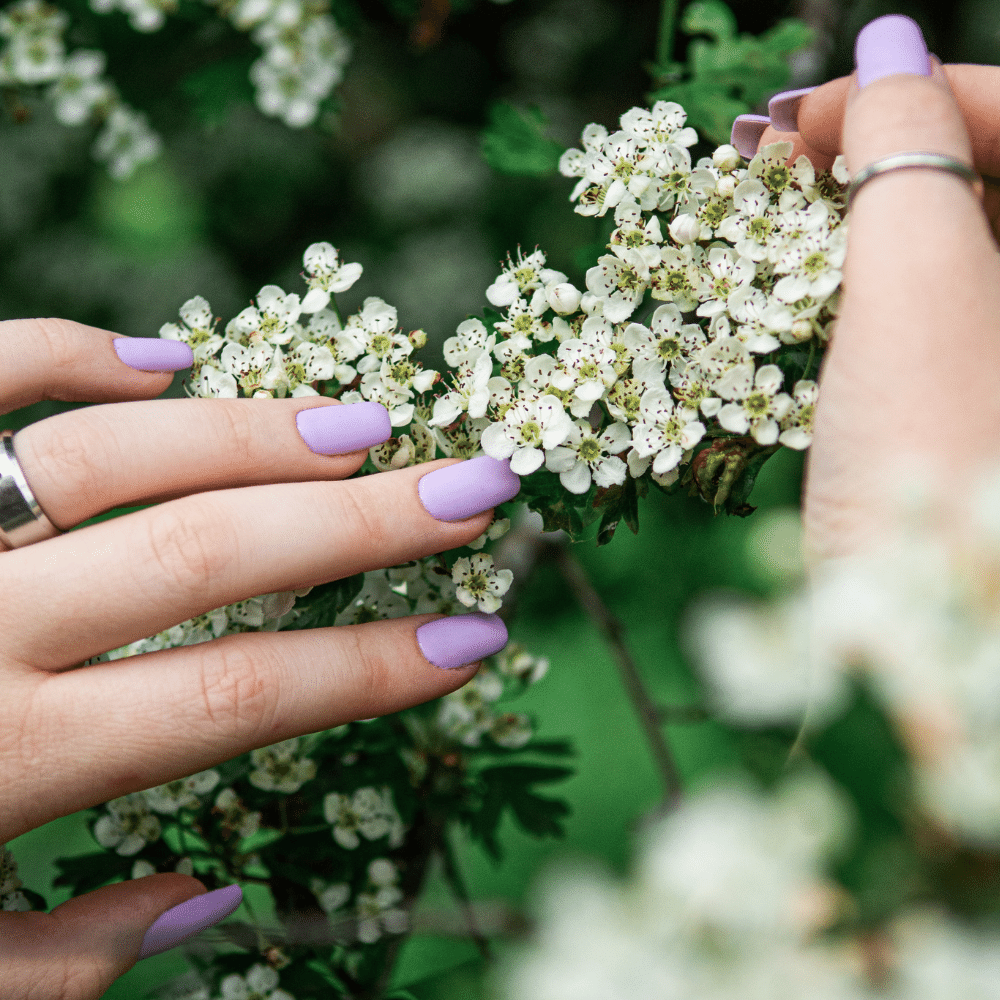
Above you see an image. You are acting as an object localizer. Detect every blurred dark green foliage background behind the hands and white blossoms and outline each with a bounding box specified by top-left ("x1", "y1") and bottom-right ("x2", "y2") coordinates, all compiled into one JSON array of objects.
[{"x1": 0, "y1": 0, "x2": 1000, "y2": 1000}]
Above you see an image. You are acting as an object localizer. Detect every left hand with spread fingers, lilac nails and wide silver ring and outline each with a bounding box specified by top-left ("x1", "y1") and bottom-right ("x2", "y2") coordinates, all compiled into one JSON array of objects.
[{"x1": 0, "y1": 320, "x2": 520, "y2": 1000}]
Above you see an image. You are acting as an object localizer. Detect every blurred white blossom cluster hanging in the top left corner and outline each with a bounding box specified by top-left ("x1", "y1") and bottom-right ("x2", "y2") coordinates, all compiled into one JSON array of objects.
[{"x1": 0, "y1": 0, "x2": 161, "y2": 178}]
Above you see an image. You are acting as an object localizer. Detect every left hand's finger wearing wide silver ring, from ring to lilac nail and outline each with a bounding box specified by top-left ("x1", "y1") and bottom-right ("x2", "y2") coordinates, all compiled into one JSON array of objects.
[{"x1": 14, "y1": 396, "x2": 392, "y2": 530}]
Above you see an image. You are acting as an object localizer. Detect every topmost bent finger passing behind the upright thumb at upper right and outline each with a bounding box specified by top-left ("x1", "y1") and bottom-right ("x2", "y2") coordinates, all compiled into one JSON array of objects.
[{"x1": 796, "y1": 63, "x2": 1000, "y2": 177}]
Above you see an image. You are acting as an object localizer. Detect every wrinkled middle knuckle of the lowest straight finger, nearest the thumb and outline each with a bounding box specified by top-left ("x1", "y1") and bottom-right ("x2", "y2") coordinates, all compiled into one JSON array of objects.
[{"x1": 198, "y1": 636, "x2": 279, "y2": 740}]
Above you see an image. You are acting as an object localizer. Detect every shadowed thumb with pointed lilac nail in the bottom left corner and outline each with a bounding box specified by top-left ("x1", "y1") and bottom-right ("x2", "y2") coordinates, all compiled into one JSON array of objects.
[{"x1": 0, "y1": 872, "x2": 243, "y2": 1000}]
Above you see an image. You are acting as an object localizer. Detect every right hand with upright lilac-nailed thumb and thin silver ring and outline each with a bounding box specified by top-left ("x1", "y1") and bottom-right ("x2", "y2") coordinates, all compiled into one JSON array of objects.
[{"x1": 740, "y1": 16, "x2": 1000, "y2": 556}]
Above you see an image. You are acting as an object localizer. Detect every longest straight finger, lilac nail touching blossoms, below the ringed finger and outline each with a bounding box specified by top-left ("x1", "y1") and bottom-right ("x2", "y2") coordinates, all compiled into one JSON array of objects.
[{"x1": 0, "y1": 456, "x2": 520, "y2": 670}]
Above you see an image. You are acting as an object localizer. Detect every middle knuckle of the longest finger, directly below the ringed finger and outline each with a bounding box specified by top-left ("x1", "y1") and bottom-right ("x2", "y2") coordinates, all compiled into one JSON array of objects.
[{"x1": 146, "y1": 497, "x2": 238, "y2": 597}]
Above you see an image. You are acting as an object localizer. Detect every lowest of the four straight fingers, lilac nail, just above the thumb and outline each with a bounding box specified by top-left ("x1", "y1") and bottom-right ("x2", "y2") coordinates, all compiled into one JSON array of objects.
[{"x1": 6, "y1": 614, "x2": 507, "y2": 839}]
